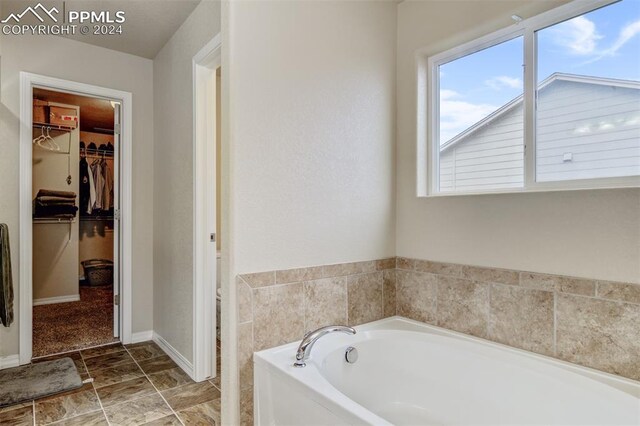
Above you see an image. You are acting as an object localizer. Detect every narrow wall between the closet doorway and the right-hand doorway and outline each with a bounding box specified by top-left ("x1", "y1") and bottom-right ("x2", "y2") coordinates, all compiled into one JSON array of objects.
[{"x1": 153, "y1": 0, "x2": 220, "y2": 361}]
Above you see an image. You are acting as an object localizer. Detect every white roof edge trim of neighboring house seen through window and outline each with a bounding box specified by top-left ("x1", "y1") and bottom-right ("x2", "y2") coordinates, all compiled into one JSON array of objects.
[{"x1": 440, "y1": 72, "x2": 640, "y2": 152}]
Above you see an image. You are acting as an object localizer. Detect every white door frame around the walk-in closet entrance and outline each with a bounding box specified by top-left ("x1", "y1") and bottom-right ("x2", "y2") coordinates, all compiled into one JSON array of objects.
[{"x1": 19, "y1": 71, "x2": 133, "y2": 365}]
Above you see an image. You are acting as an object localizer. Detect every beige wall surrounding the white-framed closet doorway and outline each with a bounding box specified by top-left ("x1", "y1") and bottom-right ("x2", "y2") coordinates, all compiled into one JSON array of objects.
[{"x1": 0, "y1": 32, "x2": 153, "y2": 356}]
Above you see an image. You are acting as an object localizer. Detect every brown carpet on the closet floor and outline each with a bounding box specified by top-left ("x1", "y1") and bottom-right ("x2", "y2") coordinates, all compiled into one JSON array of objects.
[{"x1": 33, "y1": 286, "x2": 117, "y2": 358}]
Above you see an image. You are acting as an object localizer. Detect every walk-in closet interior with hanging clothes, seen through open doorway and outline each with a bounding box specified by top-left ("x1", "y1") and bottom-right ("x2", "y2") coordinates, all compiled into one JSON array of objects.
[{"x1": 32, "y1": 88, "x2": 119, "y2": 358}]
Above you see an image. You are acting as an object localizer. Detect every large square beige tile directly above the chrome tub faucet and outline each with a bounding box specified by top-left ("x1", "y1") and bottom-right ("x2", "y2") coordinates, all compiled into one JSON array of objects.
[{"x1": 304, "y1": 277, "x2": 347, "y2": 332}]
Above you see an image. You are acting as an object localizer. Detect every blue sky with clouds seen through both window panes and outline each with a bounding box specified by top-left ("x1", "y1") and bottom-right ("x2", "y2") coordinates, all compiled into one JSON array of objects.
[{"x1": 440, "y1": 0, "x2": 640, "y2": 143}]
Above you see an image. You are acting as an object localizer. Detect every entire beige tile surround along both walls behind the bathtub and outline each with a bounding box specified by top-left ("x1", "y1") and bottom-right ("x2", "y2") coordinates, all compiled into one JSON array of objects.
[{"x1": 236, "y1": 257, "x2": 640, "y2": 424}]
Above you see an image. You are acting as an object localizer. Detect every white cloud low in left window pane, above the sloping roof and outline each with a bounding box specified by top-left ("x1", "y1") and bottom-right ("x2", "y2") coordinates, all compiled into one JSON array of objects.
[{"x1": 440, "y1": 90, "x2": 498, "y2": 144}]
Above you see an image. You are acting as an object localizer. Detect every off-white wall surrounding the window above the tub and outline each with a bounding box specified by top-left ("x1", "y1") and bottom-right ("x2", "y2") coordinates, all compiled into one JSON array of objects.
[{"x1": 396, "y1": 1, "x2": 640, "y2": 282}]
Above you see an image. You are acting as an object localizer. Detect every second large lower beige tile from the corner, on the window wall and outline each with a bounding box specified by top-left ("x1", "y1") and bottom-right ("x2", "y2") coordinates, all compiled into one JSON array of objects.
[{"x1": 436, "y1": 275, "x2": 489, "y2": 337}]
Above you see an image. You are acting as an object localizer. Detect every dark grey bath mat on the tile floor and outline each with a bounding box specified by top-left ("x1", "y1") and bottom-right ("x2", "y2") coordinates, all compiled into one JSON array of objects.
[{"x1": 0, "y1": 358, "x2": 82, "y2": 407}]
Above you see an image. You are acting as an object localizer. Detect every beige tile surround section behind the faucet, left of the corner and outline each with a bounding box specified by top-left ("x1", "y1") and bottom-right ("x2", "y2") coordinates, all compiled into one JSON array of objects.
[{"x1": 236, "y1": 258, "x2": 396, "y2": 425}]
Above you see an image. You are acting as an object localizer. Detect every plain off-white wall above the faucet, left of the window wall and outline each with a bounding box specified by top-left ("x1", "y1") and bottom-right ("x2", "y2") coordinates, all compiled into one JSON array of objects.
[{"x1": 228, "y1": 1, "x2": 396, "y2": 273}]
